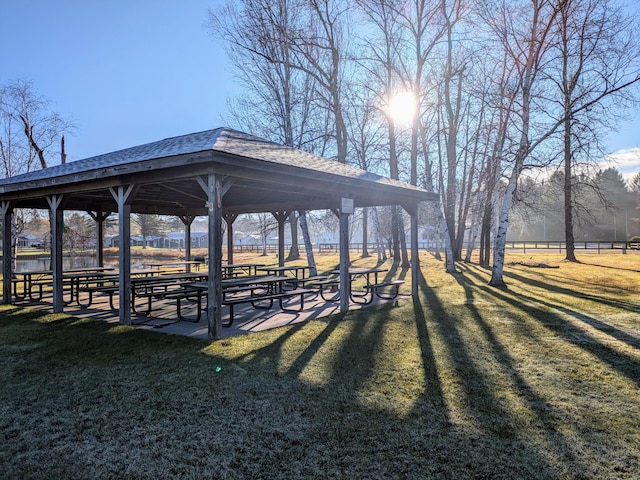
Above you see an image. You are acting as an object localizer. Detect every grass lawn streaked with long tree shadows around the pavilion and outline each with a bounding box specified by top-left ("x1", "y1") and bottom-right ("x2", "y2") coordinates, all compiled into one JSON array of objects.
[{"x1": 0, "y1": 253, "x2": 640, "y2": 479}]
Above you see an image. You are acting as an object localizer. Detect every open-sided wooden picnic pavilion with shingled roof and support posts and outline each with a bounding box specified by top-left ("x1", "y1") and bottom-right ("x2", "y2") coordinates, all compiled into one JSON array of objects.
[{"x1": 0, "y1": 128, "x2": 437, "y2": 339}]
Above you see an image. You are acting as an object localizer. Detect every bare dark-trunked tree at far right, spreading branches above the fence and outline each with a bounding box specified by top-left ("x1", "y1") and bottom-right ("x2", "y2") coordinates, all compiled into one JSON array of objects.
[{"x1": 554, "y1": 0, "x2": 640, "y2": 262}]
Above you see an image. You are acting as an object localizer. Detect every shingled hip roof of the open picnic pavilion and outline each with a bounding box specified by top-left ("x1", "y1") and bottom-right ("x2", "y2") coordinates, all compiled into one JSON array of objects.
[{"x1": 0, "y1": 128, "x2": 436, "y2": 215}]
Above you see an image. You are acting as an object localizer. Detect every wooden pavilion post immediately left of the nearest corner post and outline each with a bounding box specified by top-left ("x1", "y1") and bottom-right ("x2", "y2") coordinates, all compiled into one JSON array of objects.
[{"x1": 109, "y1": 185, "x2": 137, "y2": 325}]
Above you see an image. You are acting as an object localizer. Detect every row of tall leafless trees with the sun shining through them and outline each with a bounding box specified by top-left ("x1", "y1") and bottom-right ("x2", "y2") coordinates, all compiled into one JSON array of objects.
[{"x1": 209, "y1": 0, "x2": 640, "y2": 286}]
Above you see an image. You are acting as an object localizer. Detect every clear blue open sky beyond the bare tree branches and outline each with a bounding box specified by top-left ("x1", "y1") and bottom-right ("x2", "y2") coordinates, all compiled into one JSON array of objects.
[{"x1": 0, "y1": 0, "x2": 640, "y2": 174}]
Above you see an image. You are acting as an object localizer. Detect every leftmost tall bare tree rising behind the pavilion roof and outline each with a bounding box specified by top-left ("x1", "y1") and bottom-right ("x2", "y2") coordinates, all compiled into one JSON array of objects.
[{"x1": 209, "y1": 0, "x2": 325, "y2": 266}]
